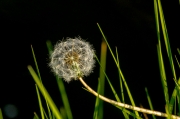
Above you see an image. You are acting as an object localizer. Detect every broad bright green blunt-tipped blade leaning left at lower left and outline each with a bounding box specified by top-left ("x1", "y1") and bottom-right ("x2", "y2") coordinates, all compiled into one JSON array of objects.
[{"x1": 28, "y1": 65, "x2": 62, "y2": 119}]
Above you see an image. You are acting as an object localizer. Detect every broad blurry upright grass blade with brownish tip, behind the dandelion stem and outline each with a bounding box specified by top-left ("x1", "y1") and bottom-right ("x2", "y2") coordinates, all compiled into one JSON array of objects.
[{"x1": 94, "y1": 39, "x2": 107, "y2": 119}]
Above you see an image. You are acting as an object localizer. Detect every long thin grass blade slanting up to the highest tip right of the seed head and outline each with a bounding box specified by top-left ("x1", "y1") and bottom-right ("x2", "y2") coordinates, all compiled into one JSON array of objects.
[{"x1": 97, "y1": 23, "x2": 139, "y2": 117}]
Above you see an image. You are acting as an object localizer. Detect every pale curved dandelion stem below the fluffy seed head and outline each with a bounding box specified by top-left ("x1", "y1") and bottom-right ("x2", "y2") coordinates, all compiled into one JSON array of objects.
[{"x1": 79, "y1": 77, "x2": 180, "y2": 119}]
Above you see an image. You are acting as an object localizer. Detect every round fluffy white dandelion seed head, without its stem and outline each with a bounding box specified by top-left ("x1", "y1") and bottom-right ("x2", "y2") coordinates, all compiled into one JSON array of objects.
[{"x1": 49, "y1": 37, "x2": 95, "y2": 82}]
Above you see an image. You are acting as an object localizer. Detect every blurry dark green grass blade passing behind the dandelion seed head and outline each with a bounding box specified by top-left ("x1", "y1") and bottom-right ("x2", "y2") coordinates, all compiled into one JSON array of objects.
[{"x1": 46, "y1": 40, "x2": 73, "y2": 119}]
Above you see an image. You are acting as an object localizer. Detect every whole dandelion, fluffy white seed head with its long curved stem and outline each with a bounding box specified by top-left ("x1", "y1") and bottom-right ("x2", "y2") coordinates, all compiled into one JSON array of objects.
[{"x1": 49, "y1": 37, "x2": 180, "y2": 119}]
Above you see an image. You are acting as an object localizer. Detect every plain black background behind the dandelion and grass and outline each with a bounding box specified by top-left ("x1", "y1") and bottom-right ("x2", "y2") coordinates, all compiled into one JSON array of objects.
[{"x1": 0, "y1": 0, "x2": 180, "y2": 119}]
